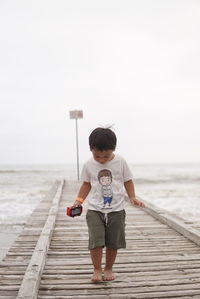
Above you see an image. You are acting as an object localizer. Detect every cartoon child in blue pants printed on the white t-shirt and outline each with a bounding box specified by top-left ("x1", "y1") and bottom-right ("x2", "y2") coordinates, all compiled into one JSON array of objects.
[{"x1": 98, "y1": 169, "x2": 113, "y2": 209}]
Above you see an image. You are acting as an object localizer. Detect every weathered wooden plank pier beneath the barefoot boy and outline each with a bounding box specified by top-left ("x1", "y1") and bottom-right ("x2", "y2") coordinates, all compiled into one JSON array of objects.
[{"x1": 0, "y1": 181, "x2": 200, "y2": 299}]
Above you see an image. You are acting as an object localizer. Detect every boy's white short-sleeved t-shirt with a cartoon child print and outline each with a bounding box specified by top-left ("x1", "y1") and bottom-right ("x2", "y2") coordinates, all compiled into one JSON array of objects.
[{"x1": 81, "y1": 155, "x2": 132, "y2": 213}]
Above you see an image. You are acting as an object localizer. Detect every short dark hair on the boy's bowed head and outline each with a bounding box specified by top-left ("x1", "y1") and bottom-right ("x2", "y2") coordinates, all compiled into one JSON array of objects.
[{"x1": 89, "y1": 128, "x2": 117, "y2": 151}]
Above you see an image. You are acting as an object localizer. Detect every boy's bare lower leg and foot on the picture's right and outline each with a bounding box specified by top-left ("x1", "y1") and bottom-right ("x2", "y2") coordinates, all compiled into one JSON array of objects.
[{"x1": 104, "y1": 248, "x2": 117, "y2": 281}]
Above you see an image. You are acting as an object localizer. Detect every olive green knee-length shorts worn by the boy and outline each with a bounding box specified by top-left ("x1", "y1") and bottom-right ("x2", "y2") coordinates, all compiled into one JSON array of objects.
[{"x1": 86, "y1": 210, "x2": 126, "y2": 249}]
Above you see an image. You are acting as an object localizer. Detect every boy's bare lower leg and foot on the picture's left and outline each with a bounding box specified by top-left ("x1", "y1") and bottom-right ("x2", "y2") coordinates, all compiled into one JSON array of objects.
[{"x1": 90, "y1": 247, "x2": 103, "y2": 282}]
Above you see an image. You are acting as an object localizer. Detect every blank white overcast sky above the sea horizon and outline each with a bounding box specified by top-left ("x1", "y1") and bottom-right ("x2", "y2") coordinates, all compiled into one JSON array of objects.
[{"x1": 0, "y1": 0, "x2": 200, "y2": 164}]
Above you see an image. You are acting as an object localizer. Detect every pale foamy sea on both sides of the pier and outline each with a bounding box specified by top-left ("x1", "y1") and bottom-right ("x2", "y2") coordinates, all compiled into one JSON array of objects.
[{"x1": 0, "y1": 163, "x2": 200, "y2": 227}]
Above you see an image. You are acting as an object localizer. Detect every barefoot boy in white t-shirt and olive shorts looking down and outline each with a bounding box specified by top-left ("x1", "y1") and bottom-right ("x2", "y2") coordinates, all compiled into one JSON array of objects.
[{"x1": 74, "y1": 128, "x2": 144, "y2": 282}]
